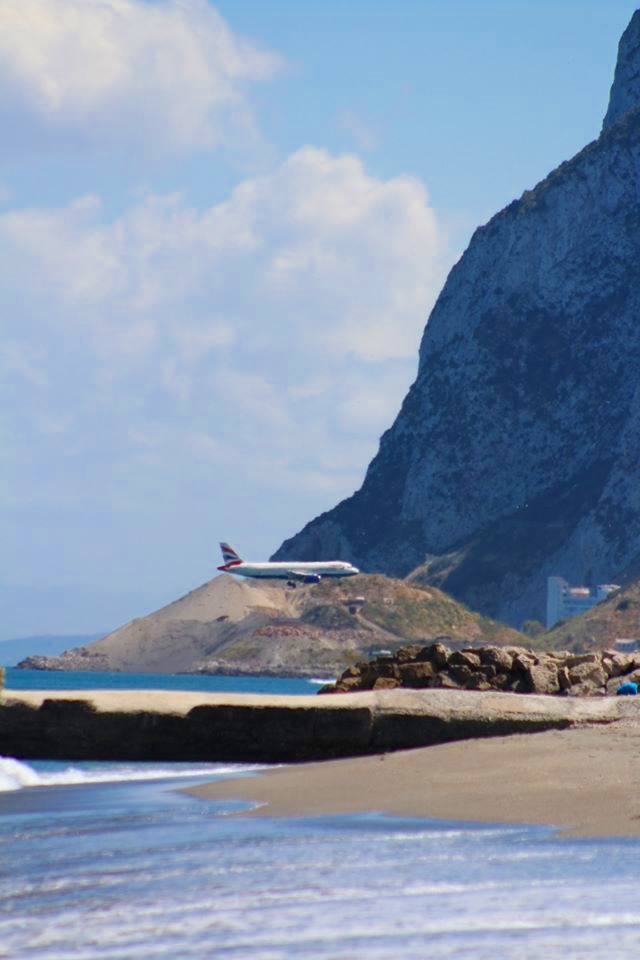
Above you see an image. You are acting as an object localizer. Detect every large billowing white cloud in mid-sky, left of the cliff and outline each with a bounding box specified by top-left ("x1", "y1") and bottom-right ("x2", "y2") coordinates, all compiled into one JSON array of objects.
[{"x1": 0, "y1": 147, "x2": 445, "y2": 506}]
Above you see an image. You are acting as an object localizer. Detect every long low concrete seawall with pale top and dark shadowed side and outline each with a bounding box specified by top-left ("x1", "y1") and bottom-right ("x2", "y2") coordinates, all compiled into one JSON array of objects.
[{"x1": 0, "y1": 690, "x2": 640, "y2": 763}]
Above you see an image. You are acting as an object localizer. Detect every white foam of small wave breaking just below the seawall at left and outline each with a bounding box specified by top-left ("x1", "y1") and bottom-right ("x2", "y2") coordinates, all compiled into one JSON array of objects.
[{"x1": 0, "y1": 757, "x2": 255, "y2": 793}]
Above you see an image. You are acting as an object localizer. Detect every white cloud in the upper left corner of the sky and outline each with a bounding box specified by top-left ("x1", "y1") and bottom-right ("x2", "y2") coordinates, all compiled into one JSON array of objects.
[{"x1": 0, "y1": 0, "x2": 281, "y2": 152}]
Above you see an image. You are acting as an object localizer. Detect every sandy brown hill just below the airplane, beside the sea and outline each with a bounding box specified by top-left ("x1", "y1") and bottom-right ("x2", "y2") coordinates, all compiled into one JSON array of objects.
[{"x1": 16, "y1": 575, "x2": 522, "y2": 675}]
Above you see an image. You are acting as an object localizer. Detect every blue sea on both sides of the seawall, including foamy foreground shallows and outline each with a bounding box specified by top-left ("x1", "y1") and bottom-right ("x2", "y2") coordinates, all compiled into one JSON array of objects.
[{"x1": 0, "y1": 671, "x2": 640, "y2": 960}]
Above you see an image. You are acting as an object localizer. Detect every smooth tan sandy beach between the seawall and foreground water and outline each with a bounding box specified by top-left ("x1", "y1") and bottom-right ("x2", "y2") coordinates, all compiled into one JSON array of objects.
[{"x1": 190, "y1": 719, "x2": 640, "y2": 837}]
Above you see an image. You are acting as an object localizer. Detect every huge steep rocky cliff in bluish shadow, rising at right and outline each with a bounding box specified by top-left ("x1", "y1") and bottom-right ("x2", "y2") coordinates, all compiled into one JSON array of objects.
[{"x1": 275, "y1": 12, "x2": 640, "y2": 624}]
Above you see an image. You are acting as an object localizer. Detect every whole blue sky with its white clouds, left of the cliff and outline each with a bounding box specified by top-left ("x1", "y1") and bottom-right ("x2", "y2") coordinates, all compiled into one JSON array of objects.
[{"x1": 0, "y1": 0, "x2": 636, "y2": 640}]
